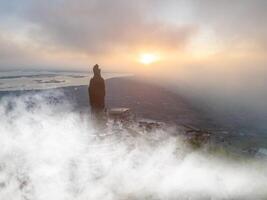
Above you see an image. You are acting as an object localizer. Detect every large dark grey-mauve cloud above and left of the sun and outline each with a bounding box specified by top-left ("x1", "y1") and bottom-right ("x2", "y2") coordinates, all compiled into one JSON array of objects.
[{"x1": 23, "y1": 0, "x2": 195, "y2": 54}]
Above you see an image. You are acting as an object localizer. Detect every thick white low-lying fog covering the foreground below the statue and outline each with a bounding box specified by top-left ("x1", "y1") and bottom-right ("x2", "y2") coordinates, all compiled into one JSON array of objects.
[{"x1": 0, "y1": 92, "x2": 267, "y2": 200}]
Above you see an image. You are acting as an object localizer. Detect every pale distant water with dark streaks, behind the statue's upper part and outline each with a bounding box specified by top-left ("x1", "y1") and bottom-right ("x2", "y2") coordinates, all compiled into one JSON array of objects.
[{"x1": 0, "y1": 71, "x2": 130, "y2": 91}]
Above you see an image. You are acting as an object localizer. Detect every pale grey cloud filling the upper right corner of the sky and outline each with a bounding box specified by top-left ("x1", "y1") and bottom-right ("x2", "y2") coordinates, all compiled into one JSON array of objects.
[{"x1": 194, "y1": 0, "x2": 267, "y2": 48}]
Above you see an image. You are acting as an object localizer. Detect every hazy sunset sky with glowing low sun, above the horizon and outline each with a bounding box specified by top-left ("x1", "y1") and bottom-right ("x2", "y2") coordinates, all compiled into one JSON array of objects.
[{"x1": 0, "y1": 0, "x2": 267, "y2": 73}]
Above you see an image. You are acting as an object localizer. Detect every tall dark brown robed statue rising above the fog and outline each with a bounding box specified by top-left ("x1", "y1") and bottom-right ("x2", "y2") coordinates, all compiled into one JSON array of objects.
[{"x1": 88, "y1": 64, "x2": 106, "y2": 113}]
